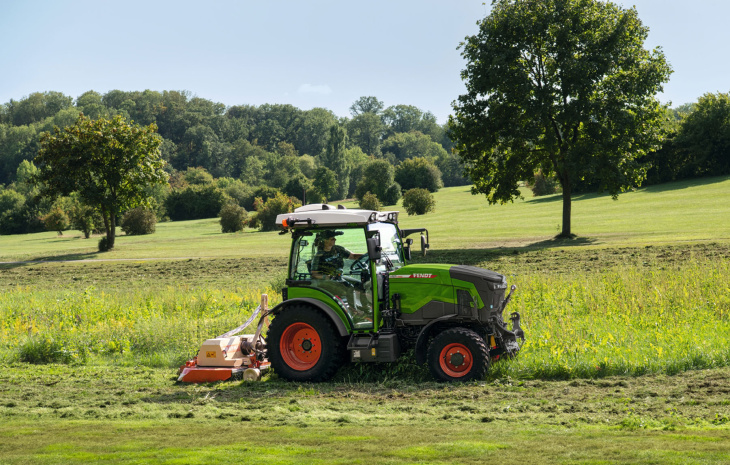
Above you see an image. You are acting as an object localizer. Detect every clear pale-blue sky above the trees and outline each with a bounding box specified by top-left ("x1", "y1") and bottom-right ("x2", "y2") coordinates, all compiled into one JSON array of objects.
[{"x1": 0, "y1": 0, "x2": 730, "y2": 124}]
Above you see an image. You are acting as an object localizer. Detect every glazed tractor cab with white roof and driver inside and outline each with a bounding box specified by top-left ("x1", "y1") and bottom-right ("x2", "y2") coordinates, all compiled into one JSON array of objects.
[{"x1": 277, "y1": 204, "x2": 407, "y2": 332}]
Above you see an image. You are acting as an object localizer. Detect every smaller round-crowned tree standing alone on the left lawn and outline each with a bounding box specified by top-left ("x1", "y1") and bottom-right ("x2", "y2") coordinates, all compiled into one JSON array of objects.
[{"x1": 35, "y1": 115, "x2": 167, "y2": 250}]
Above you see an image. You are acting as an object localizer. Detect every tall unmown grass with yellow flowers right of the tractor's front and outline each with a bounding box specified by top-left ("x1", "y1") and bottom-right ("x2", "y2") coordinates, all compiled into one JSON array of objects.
[{"x1": 494, "y1": 260, "x2": 730, "y2": 378}]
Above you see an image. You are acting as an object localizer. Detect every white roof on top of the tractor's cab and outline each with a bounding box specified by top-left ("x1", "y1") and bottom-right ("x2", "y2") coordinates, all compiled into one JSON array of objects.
[{"x1": 276, "y1": 203, "x2": 399, "y2": 230}]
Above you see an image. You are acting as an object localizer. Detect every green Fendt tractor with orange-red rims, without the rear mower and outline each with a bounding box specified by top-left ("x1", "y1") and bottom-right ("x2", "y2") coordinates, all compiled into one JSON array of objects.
[{"x1": 266, "y1": 204, "x2": 524, "y2": 381}]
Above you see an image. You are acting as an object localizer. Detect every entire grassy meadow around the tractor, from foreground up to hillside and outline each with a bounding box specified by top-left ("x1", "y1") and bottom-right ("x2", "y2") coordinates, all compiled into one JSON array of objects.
[{"x1": 0, "y1": 178, "x2": 730, "y2": 463}]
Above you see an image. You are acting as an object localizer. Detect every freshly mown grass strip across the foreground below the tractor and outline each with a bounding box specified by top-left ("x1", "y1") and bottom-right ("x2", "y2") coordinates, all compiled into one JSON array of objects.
[{"x1": 0, "y1": 364, "x2": 730, "y2": 464}]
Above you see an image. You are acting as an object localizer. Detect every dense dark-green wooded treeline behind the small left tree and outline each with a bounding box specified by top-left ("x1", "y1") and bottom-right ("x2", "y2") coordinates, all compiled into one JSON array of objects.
[{"x1": 0, "y1": 90, "x2": 469, "y2": 234}]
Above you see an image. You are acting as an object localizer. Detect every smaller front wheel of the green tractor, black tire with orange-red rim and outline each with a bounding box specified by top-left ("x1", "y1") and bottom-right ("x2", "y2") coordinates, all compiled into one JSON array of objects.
[{"x1": 426, "y1": 328, "x2": 489, "y2": 381}]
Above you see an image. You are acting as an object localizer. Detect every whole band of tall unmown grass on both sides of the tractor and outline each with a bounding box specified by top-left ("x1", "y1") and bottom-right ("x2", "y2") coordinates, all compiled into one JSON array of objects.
[{"x1": 0, "y1": 254, "x2": 730, "y2": 379}]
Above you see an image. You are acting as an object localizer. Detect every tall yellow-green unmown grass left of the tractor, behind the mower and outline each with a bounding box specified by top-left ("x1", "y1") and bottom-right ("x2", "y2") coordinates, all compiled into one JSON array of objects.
[{"x1": 0, "y1": 287, "x2": 280, "y2": 366}]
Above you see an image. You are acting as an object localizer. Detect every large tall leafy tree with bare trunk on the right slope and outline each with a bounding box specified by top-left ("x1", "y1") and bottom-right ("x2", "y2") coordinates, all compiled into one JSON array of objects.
[{"x1": 449, "y1": 0, "x2": 671, "y2": 237}]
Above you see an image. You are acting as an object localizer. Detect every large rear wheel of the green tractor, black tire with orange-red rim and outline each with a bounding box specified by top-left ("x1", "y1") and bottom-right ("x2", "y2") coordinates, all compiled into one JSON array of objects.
[{"x1": 266, "y1": 305, "x2": 345, "y2": 382}]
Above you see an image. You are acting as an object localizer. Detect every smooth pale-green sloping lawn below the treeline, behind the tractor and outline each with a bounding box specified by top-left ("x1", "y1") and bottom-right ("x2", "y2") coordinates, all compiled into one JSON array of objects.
[{"x1": 0, "y1": 177, "x2": 730, "y2": 261}]
